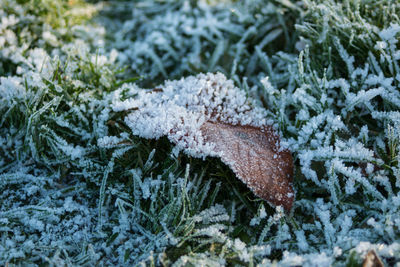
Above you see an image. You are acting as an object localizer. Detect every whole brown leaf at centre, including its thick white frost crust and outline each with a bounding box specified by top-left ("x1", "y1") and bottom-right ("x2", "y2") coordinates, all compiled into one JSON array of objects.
[{"x1": 113, "y1": 73, "x2": 294, "y2": 210}]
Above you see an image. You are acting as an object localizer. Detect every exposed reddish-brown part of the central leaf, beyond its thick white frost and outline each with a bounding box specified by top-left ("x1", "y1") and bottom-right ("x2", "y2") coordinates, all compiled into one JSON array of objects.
[{"x1": 200, "y1": 122, "x2": 294, "y2": 211}]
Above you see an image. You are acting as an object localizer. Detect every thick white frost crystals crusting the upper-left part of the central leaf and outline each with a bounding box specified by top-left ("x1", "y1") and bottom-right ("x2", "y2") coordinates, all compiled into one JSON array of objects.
[{"x1": 113, "y1": 73, "x2": 267, "y2": 158}]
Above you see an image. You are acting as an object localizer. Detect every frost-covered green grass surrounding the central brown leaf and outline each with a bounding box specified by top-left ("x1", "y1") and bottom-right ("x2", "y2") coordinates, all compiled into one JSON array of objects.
[{"x1": 0, "y1": 0, "x2": 400, "y2": 266}]
